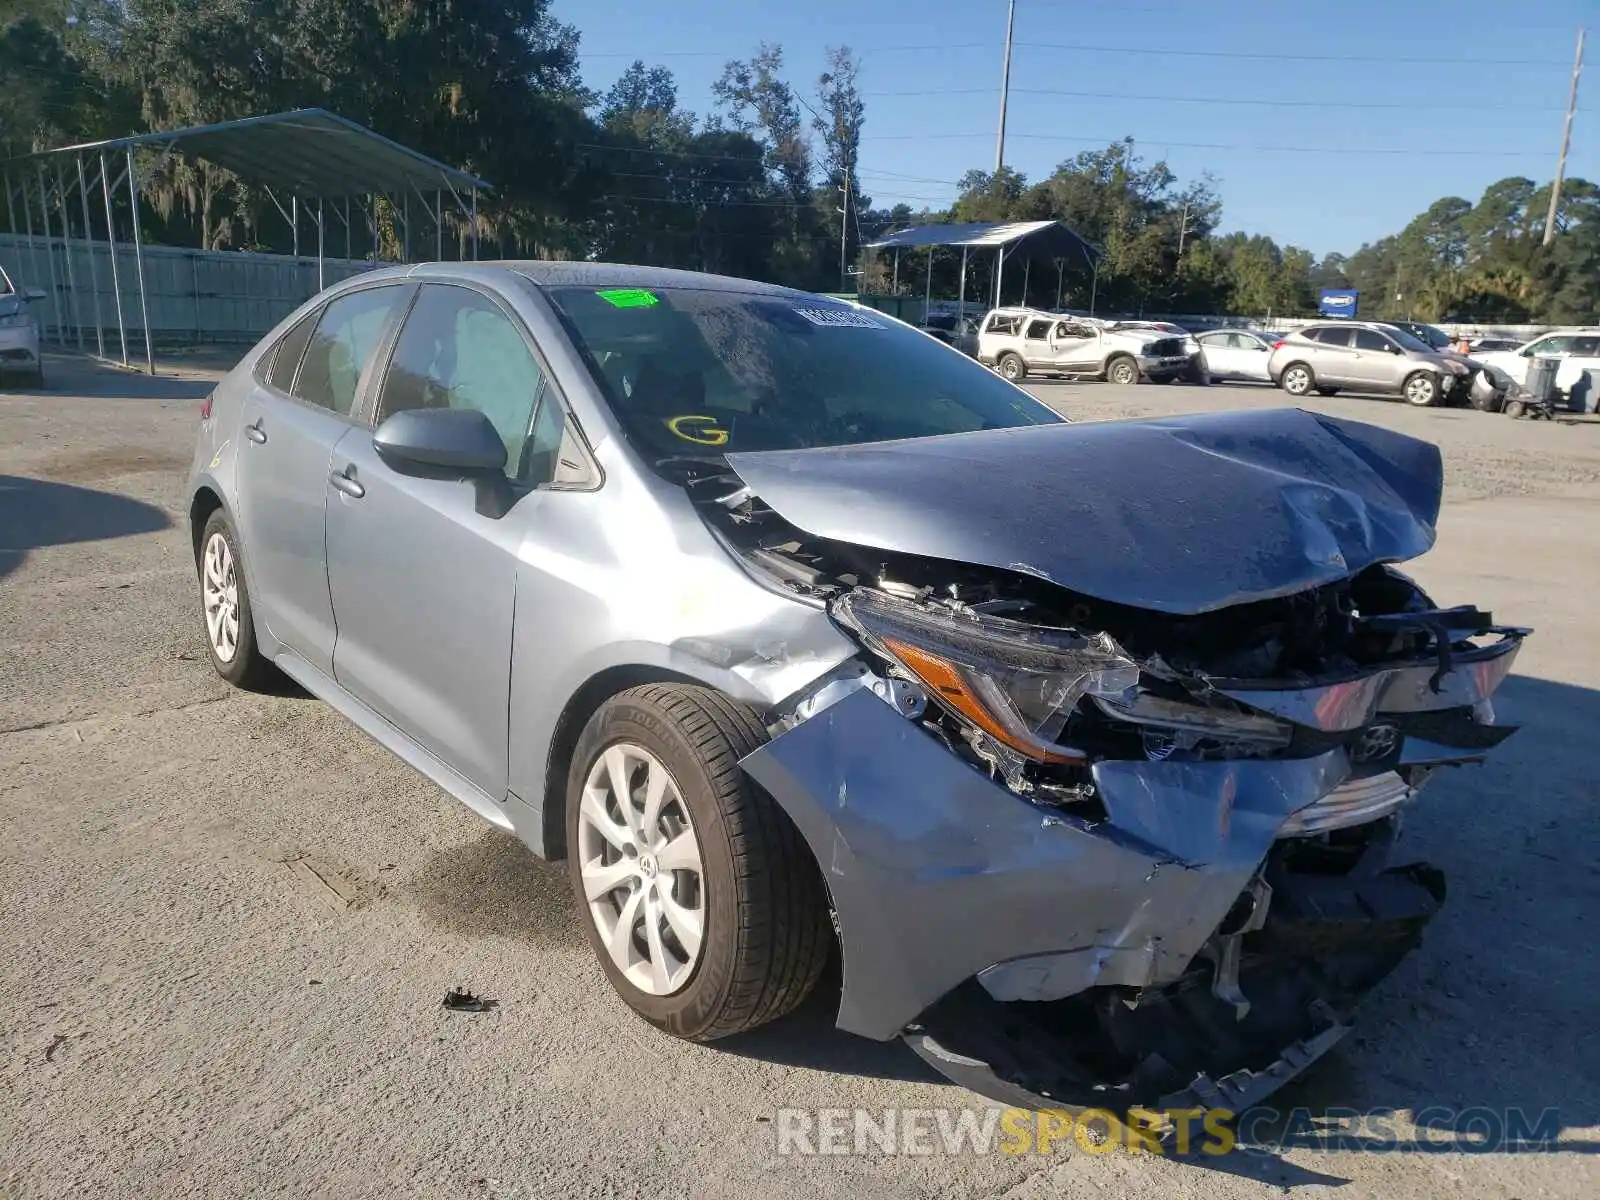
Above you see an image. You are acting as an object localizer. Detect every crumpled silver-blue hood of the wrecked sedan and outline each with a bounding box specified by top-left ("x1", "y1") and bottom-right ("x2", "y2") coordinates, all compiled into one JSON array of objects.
[{"x1": 728, "y1": 408, "x2": 1443, "y2": 614}]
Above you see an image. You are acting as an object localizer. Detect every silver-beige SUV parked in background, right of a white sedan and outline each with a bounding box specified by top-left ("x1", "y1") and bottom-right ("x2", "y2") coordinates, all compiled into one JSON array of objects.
[{"x1": 1267, "y1": 320, "x2": 1472, "y2": 405}]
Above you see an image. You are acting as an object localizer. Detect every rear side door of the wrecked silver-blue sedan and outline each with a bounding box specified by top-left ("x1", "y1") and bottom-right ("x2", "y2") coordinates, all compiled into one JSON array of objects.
[{"x1": 234, "y1": 283, "x2": 406, "y2": 672}]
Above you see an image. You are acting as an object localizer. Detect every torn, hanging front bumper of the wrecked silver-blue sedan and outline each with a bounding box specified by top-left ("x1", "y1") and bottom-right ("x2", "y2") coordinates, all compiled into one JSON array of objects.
[{"x1": 742, "y1": 643, "x2": 1515, "y2": 1107}]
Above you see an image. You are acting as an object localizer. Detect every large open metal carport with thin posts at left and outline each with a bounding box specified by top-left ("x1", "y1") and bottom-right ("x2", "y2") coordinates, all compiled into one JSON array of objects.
[{"x1": 0, "y1": 109, "x2": 490, "y2": 374}]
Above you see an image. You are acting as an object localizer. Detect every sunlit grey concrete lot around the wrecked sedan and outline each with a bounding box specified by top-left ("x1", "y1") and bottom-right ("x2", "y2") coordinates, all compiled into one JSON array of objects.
[{"x1": 9, "y1": 360, "x2": 1600, "y2": 1200}]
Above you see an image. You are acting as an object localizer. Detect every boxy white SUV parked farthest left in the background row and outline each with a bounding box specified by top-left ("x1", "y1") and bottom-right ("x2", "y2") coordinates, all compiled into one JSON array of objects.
[{"x1": 978, "y1": 309, "x2": 1189, "y2": 384}]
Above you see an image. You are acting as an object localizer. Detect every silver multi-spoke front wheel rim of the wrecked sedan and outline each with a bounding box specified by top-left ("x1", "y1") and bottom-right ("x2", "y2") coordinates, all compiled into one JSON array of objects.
[{"x1": 578, "y1": 742, "x2": 706, "y2": 995}]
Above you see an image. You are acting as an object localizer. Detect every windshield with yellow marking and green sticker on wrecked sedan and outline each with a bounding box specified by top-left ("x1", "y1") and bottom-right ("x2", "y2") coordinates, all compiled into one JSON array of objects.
[{"x1": 546, "y1": 286, "x2": 1062, "y2": 459}]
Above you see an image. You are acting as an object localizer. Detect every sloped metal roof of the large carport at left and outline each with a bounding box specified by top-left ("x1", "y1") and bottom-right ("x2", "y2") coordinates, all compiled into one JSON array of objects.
[{"x1": 4, "y1": 109, "x2": 488, "y2": 197}]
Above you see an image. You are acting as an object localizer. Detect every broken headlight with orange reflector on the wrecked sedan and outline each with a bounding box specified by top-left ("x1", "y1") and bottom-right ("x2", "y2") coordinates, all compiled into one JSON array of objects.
[{"x1": 832, "y1": 590, "x2": 1139, "y2": 763}]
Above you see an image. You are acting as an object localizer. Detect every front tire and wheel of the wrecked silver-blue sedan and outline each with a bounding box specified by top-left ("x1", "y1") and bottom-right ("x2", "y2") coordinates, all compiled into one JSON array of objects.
[{"x1": 566, "y1": 685, "x2": 832, "y2": 1042}]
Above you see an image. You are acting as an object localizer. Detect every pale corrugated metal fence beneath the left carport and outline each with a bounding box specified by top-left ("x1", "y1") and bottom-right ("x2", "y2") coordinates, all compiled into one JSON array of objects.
[{"x1": 0, "y1": 234, "x2": 387, "y2": 357}]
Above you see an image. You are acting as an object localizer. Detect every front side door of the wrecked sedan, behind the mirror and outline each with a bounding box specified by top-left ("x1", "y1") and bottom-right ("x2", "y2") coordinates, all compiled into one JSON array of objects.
[{"x1": 325, "y1": 283, "x2": 563, "y2": 798}]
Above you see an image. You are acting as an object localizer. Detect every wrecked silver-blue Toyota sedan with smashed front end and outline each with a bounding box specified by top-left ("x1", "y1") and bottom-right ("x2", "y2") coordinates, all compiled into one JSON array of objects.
[{"x1": 190, "y1": 262, "x2": 1528, "y2": 1110}]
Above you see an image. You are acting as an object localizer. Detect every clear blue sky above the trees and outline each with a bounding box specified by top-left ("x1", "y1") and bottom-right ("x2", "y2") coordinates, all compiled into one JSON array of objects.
[{"x1": 554, "y1": 0, "x2": 1600, "y2": 254}]
